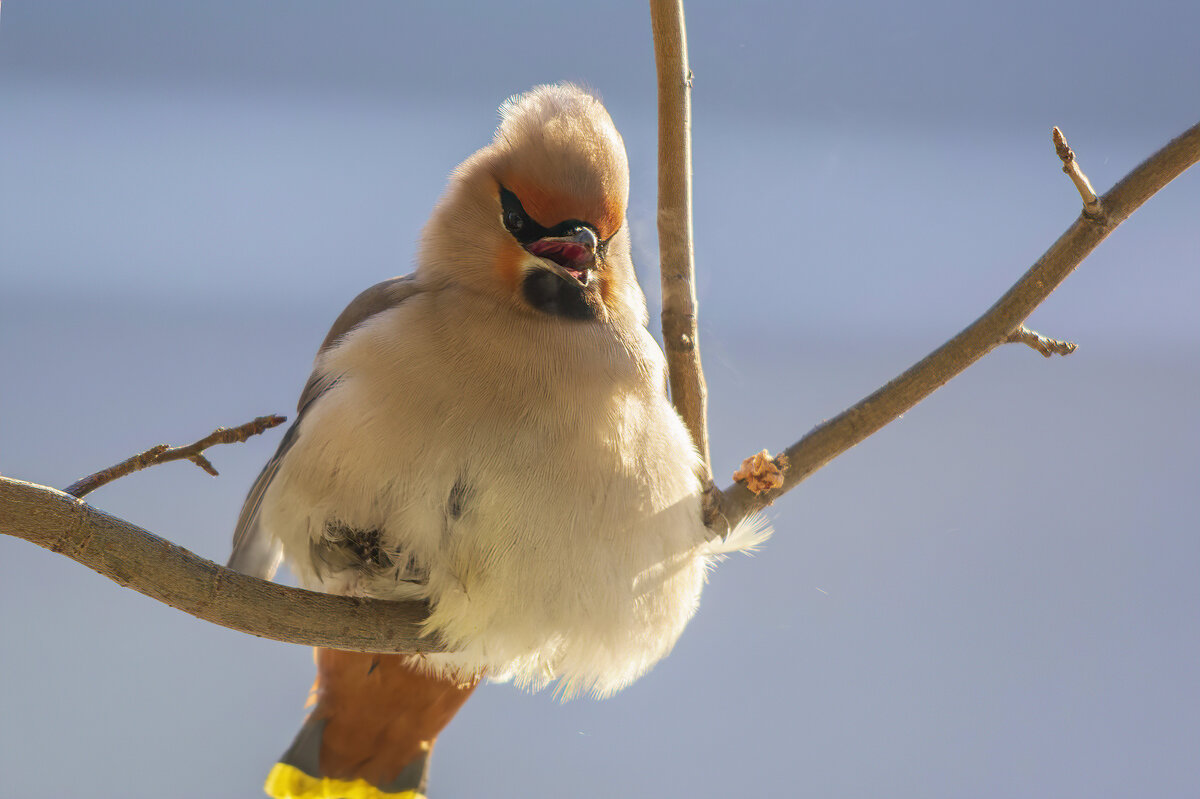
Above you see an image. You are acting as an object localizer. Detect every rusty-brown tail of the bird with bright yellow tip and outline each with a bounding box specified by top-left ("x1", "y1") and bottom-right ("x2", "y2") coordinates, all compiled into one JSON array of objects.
[{"x1": 264, "y1": 649, "x2": 476, "y2": 799}]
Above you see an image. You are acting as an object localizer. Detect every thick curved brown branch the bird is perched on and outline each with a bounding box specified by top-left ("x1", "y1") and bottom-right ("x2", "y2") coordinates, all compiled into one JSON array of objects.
[{"x1": 0, "y1": 477, "x2": 442, "y2": 653}]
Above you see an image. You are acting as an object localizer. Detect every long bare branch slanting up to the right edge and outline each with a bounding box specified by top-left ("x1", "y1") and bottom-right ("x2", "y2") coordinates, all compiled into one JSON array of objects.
[{"x1": 709, "y1": 119, "x2": 1200, "y2": 533}]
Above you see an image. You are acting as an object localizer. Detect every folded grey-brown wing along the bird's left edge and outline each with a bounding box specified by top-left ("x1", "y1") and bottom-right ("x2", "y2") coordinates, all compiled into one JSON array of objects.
[{"x1": 228, "y1": 275, "x2": 419, "y2": 579}]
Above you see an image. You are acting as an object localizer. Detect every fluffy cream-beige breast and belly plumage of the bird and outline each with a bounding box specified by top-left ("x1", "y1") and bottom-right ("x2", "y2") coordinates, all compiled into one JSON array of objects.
[{"x1": 263, "y1": 287, "x2": 764, "y2": 696}]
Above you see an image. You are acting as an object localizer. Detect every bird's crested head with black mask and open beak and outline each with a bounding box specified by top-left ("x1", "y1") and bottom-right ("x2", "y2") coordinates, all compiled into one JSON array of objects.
[{"x1": 420, "y1": 84, "x2": 646, "y2": 324}]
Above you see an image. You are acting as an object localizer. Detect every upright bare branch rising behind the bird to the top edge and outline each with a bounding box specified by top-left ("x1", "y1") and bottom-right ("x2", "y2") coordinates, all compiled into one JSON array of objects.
[{"x1": 650, "y1": 0, "x2": 713, "y2": 486}]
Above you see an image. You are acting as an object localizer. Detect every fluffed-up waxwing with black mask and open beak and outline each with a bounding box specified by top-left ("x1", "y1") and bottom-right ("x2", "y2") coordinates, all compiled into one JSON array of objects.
[{"x1": 229, "y1": 83, "x2": 769, "y2": 799}]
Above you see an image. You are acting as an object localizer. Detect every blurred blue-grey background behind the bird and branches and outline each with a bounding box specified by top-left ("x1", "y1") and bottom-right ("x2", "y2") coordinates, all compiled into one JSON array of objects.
[{"x1": 0, "y1": 0, "x2": 1200, "y2": 799}]
